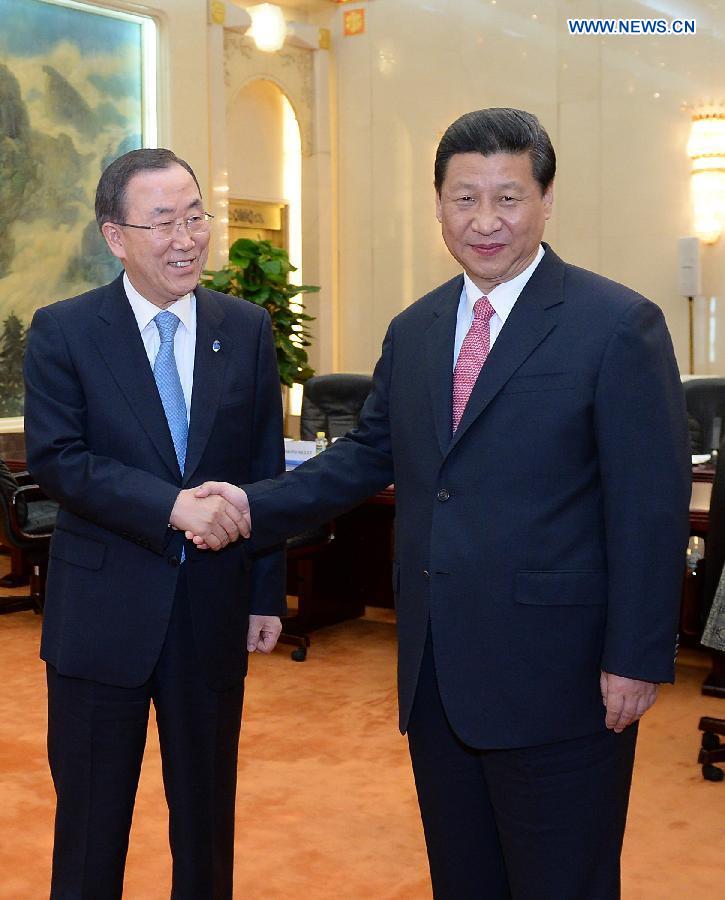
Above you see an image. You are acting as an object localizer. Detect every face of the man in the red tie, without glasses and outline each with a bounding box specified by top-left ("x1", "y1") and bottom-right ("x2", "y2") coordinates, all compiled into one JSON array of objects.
[{"x1": 436, "y1": 153, "x2": 554, "y2": 294}]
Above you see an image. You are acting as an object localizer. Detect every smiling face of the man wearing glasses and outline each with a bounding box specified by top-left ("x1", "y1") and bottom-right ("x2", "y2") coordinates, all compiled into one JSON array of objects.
[{"x1": 102, "y1": 165, "x2": 209, "y2": 309}]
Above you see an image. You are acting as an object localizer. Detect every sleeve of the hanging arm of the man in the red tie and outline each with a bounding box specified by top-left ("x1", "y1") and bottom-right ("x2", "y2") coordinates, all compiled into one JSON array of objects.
[{"x1": 595, "y1": 300, "x2": 691, "y2": 682}]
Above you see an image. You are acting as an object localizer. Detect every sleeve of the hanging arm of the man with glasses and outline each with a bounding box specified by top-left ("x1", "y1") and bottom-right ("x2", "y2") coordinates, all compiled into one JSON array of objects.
[{"x1": 250, "y1": 314, "x2": 287, "y2": 616}]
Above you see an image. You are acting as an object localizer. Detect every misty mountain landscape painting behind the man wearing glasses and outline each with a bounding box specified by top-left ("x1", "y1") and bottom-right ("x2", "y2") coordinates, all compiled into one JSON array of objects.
[{"x1": 0, "y1": 0, "x2": 151, "y2": 417}]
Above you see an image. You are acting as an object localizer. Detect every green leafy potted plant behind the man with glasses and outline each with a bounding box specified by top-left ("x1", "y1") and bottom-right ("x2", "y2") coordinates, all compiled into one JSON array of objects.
[{"x1": 201, "y1": 238, "x2": 320, "y2": 387}]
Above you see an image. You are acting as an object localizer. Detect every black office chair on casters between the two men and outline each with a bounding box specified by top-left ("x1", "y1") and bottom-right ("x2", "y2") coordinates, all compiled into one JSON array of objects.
[{"x1": 280, "y1": 373, "x2": 372, "y2": 662}]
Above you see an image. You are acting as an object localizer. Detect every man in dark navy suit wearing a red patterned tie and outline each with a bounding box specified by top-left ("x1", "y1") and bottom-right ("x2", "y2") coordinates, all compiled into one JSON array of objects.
[{"x1": 197, "y1": 109, "x2": 690, "y2": 900}]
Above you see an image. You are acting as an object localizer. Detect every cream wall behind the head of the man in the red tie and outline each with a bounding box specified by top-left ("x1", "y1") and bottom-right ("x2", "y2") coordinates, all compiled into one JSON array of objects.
[{"x1": 333, "y1": 0, "x2": 725, "y2": 371}]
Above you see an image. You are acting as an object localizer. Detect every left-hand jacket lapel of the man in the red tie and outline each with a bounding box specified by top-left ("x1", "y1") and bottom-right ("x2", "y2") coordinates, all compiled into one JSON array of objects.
[{"x1": 425, "y1": 275, "x2": 463, "y2": 454}]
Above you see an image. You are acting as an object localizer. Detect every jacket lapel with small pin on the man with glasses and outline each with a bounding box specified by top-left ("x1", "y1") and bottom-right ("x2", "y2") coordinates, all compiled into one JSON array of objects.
[{"x1": 184, "y1": 287, "x2": 228, "y2": 484}]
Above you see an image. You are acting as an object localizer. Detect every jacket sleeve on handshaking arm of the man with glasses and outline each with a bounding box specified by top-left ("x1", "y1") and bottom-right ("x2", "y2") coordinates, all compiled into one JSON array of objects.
[{"x1": 25, "y1": 309, "x2": 179, "y2": 553}]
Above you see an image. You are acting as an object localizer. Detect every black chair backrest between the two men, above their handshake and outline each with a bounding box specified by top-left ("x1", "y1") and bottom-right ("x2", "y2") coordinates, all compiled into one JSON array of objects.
[{"x1": 300, "y1": 373, "x2": 373, "y2": 441}]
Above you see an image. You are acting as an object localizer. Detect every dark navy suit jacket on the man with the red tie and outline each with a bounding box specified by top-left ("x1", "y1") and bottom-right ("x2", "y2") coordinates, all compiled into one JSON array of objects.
[{"x1": 248, "y1": 247, "x2": 690, "y2": 748}]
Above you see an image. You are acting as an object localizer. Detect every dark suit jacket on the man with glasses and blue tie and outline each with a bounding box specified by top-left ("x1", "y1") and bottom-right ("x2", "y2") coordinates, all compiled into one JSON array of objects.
[{"x1": 25, "y1": 277, "x2": 284, "y2": 689}]
